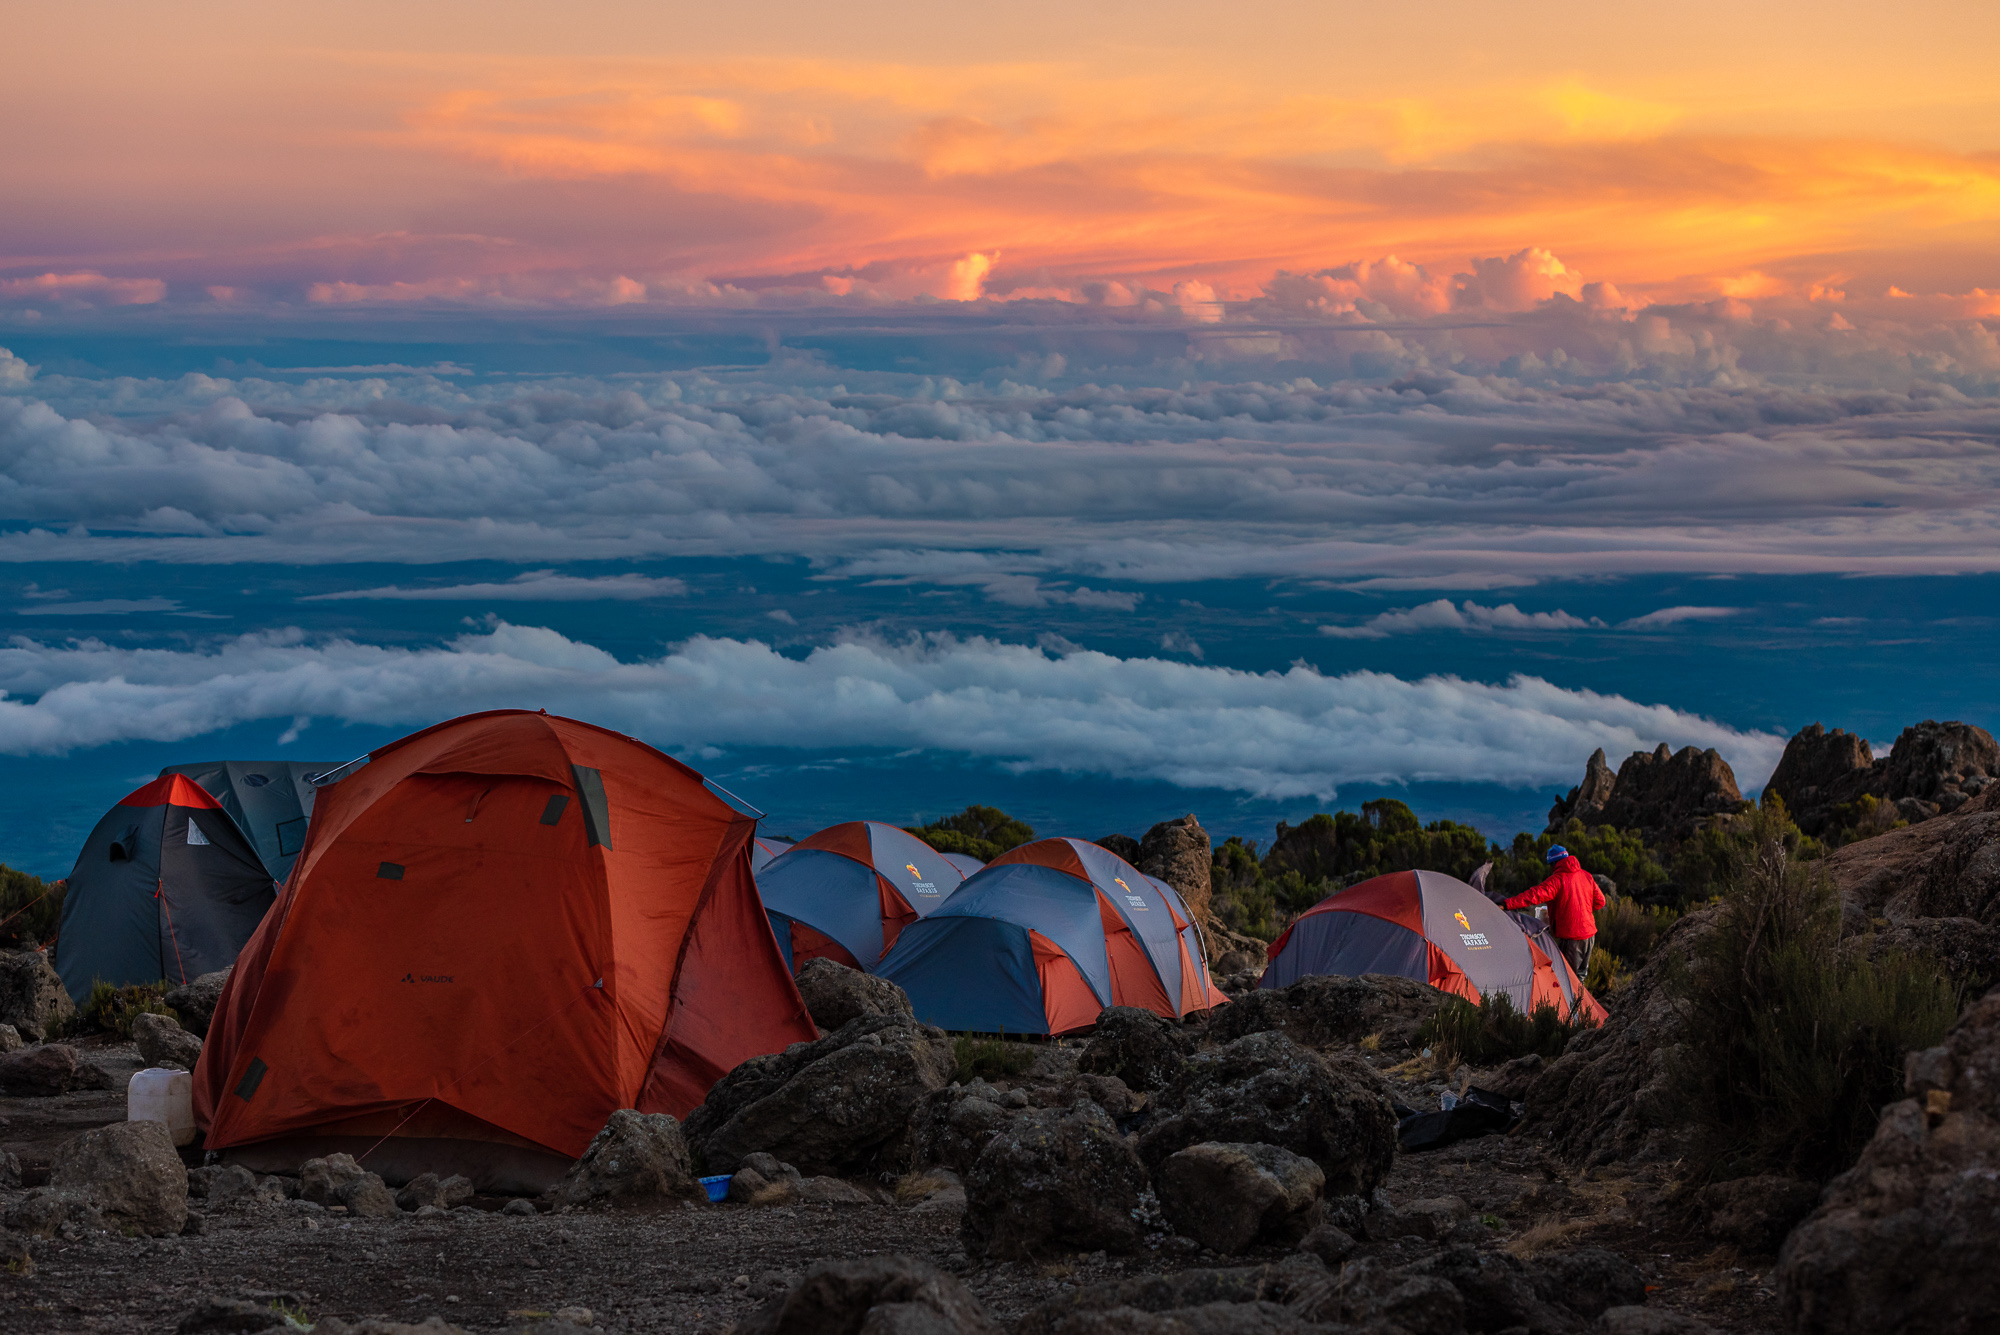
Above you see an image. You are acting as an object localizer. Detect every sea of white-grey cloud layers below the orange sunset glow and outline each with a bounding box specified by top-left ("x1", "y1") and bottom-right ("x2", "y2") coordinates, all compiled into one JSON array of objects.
[{"x1": 0, "y1": 279, "x2": 2000, "y2": 797}]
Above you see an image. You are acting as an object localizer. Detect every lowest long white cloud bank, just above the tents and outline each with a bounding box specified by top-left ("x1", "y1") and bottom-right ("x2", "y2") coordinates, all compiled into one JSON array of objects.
[{"x1": 0, "y1": 622, "x2": 1784, "y2": 801}]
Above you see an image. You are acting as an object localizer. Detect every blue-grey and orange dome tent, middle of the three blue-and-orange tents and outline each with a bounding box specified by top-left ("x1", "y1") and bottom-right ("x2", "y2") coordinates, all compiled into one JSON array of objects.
[{"x1": 876, "y1": 839, "x2": 1226, "y2": 1033}]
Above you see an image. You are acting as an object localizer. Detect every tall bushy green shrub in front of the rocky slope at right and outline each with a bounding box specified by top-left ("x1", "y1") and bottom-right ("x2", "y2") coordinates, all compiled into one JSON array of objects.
[{"x1": 1664, "y1": 803, "x2": 1958, "y2": 1181}]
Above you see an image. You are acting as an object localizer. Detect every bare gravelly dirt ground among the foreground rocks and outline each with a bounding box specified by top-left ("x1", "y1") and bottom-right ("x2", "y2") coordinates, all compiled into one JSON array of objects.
[{"x1": 0, "y1": 1043, "x2": 1778, "y2": 1335}]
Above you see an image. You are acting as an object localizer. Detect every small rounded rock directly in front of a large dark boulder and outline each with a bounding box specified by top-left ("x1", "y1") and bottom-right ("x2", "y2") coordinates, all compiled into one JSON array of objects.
[{"x1": 1152, "y1": 1141, "x2": 1326, "y2": 1255}]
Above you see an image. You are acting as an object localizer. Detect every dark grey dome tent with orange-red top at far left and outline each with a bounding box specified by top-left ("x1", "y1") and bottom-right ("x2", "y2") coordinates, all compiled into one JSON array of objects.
[{"x1": 56, "y1": 773, "x2": 276, "y2": 1001}]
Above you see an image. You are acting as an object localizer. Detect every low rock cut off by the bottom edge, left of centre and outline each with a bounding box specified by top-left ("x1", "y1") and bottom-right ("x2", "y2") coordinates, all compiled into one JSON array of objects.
[{"x1": 734, "y1": 1257, "x2": 1002, "y2": 1335}]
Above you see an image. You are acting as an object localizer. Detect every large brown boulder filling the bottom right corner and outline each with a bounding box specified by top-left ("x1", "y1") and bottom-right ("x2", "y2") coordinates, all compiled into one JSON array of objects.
[{"x1": 1776, "y1": 991, "x2": 2000, "y2": 1335}]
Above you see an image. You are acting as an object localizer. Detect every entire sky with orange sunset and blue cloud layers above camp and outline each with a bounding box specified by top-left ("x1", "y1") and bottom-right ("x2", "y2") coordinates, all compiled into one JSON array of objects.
[{"x1": 0, "y1": 0, "x2": 2000, "y2": 873}]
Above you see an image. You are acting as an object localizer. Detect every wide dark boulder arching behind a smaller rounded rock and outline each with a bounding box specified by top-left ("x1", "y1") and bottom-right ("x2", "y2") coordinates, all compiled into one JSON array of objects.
[{"x1": 1138, "y1": 1033, "x2": 1396, "y2": 1195}]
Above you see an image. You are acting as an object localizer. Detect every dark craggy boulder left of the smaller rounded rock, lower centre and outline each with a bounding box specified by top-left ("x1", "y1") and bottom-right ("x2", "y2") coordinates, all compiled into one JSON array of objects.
[{"x1": 960, "y1": 1103, "x2": 1146, "y2": 1259}]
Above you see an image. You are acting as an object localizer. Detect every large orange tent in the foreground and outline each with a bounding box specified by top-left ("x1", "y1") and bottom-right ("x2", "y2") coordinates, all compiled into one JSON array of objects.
[{"x1": 194, "y1": 709, "x2": 816, "y2": 1189}]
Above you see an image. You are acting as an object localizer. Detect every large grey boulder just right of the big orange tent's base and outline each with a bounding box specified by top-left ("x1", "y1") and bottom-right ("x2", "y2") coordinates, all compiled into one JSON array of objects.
[{"x1": 682, "y1": 1015, "x2": 958, "y2": 1177}]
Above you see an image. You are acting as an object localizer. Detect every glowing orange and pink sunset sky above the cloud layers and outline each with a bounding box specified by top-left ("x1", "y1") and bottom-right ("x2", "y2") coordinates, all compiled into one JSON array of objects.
[{"x1": 0, "y1": 0, "x2": 2000, "y2": 307}]
